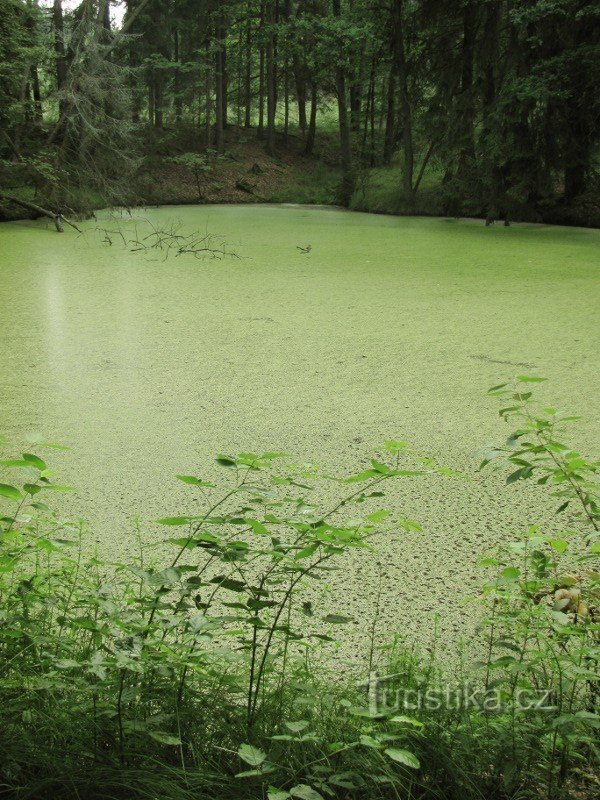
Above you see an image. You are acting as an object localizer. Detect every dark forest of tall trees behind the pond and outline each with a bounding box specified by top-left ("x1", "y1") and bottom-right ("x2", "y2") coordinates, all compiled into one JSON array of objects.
[{"x1": 0, "y1": 0, "x2": 600, "y2": 224}]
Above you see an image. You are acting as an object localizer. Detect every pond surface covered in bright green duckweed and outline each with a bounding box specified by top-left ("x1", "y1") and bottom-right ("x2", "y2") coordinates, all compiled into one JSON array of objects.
[{"x1": 0, "y1": 206, "x2": 600, "y2": 664}]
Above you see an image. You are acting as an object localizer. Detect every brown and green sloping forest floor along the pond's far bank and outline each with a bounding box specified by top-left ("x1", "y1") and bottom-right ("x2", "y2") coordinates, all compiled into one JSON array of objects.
[{"x1": 0, "y1": 125, "x2": 600, "y2": 227}]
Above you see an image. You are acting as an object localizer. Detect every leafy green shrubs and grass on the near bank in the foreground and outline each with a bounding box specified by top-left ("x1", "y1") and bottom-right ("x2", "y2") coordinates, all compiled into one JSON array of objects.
[{"x1": 0, "y1": 384, "x2": 600, "y2": 800}]
